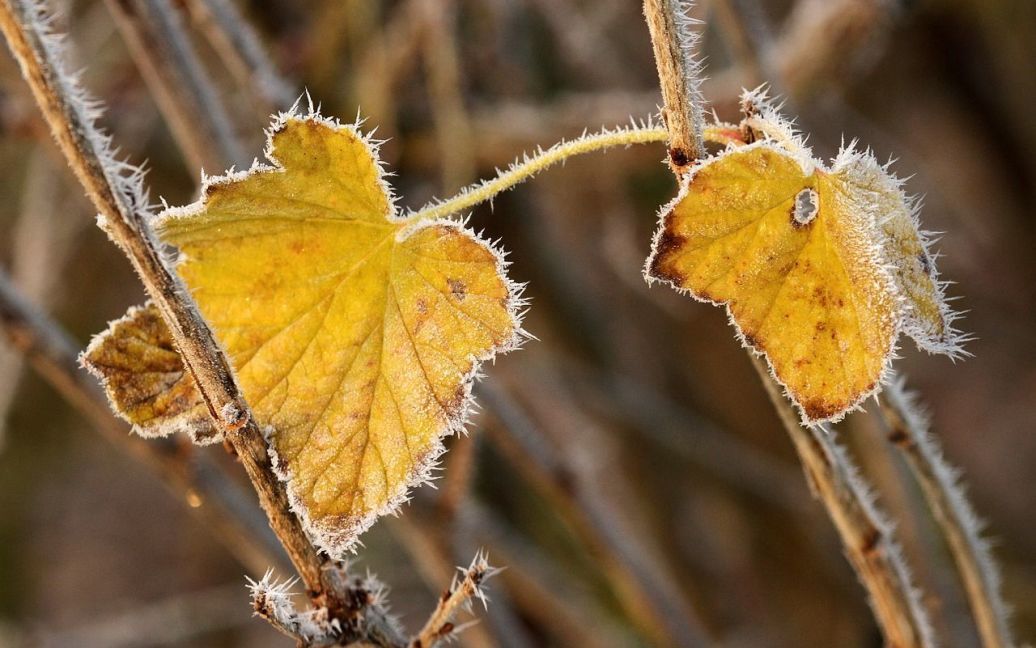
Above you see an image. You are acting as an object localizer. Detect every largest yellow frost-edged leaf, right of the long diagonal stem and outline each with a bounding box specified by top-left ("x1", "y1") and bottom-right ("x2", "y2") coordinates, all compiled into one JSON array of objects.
[{"x1": 157, "y1": 115, "x2": 520, "y2": 555}]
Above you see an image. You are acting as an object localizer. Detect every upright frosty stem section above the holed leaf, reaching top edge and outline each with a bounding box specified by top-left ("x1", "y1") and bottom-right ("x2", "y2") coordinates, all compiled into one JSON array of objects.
[{"x1": 644, "y1": 0, "x2": 706, "y2": 175}]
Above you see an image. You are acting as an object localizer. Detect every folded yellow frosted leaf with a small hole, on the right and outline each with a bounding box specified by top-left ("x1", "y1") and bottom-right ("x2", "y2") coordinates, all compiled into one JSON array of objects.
[{"x1": 645, "y1": 117, "x2": 960, "y2": 423}]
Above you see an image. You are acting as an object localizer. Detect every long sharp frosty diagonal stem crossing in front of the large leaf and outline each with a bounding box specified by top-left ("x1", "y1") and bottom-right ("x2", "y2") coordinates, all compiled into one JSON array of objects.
[{"x1": 0, "y1": 0, "x2": 347, "y2": 615}]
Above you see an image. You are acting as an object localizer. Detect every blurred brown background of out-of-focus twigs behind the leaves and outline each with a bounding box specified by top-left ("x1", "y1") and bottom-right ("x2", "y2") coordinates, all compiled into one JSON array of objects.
[{"x1": 0, "y1": 0, "x2": 1036, "y2": 647}]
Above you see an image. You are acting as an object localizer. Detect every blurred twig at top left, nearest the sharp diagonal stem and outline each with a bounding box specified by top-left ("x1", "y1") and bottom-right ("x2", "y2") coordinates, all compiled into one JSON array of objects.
[{"x1": 107, "y1": 0, "x2": 248, "y2": 171}]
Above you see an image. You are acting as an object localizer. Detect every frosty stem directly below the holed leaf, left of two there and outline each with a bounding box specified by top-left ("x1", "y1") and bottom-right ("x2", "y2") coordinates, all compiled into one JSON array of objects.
[{"x1": 752, "y1": 357, "x2": 934, "y2": 648}]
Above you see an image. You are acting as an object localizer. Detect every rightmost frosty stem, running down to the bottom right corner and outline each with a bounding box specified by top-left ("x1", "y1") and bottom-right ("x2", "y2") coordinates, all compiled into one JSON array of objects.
[{"x1": 879, "y1": 379, "x2": 1014, "y2": 648}]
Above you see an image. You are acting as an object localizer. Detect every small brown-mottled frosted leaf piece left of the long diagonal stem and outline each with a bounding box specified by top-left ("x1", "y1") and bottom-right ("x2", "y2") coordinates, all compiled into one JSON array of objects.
[{"x1": 80, "y1": 302, "x2": 218, "y2": 443}]
